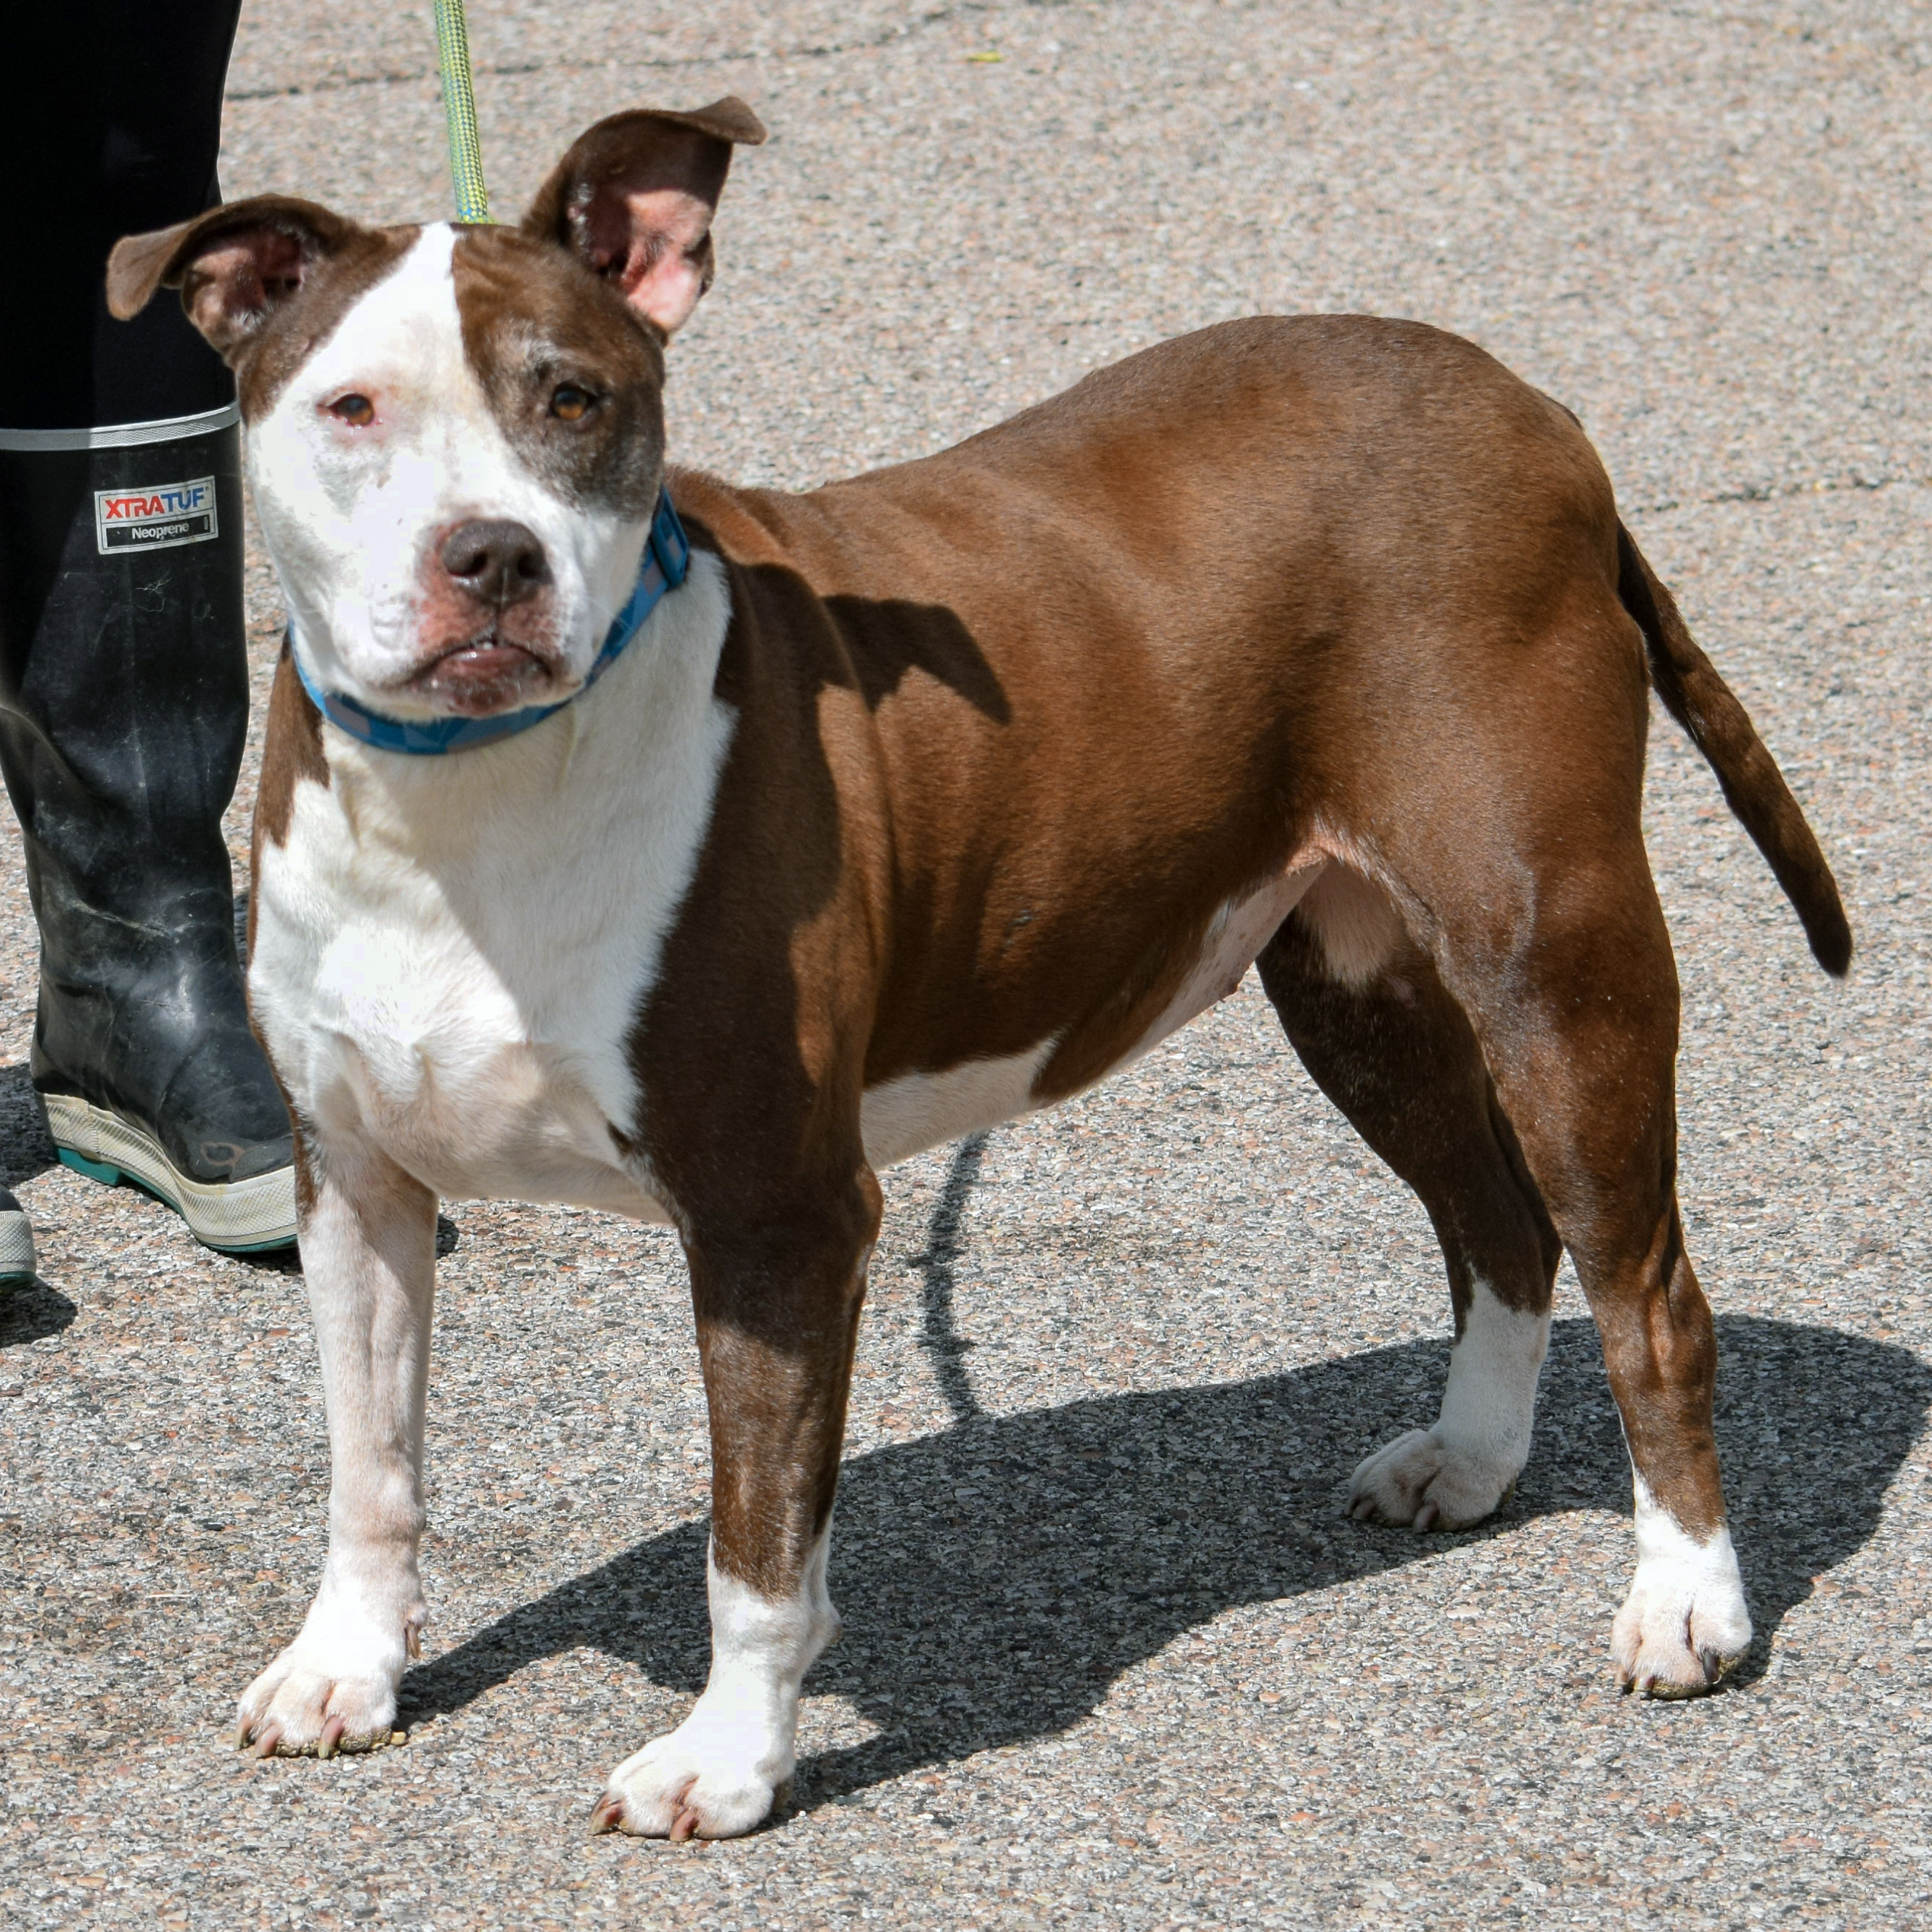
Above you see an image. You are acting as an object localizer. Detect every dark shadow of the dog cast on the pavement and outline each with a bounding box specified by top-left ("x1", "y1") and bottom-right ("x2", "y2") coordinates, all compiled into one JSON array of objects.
[{"x1": 402, "y1": 1316, "x2": 1932, "y2": 1803}]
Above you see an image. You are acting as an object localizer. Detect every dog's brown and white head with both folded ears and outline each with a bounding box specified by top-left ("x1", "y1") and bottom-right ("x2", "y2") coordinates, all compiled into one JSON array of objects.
[{"x1": 108, "y1": 99, "x2": 765, "y2": 719}]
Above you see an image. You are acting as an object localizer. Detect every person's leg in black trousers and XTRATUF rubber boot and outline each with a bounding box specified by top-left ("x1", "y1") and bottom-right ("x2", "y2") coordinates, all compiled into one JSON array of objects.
[{"x1": 0, "y1": 0, "x2": 294, "y2": 1250}]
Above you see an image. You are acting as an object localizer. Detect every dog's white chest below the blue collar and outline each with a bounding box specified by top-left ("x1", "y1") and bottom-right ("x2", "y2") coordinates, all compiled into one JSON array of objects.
[{"x1": 249, "y1": 557, "x2": 730, "y2": 1217}]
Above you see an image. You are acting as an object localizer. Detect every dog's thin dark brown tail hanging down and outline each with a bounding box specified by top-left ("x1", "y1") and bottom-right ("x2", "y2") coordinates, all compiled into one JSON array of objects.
[{"x1": 1617, "y1": 523, "x2": 1851, "y2": 978}]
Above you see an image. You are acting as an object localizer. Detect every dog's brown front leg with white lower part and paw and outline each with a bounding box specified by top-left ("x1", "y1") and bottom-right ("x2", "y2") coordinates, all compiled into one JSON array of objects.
[{"x1": 593, "y1": 1173, "x2": 879, "y2": 1838}]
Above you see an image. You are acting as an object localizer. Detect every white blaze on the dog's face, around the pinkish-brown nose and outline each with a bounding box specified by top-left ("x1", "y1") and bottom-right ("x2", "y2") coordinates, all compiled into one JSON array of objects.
[{"x1": 247, "y1": 224, "x2": 649, "y2": 719}]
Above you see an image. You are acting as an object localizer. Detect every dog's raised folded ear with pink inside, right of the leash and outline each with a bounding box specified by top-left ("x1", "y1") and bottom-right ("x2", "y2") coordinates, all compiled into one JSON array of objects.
[{"x1": 523, "y1": 94, "x2": 765, "y2": 336}]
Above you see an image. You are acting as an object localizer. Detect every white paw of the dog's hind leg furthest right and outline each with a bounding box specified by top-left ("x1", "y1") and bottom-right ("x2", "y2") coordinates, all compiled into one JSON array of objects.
[{"x1": 1609, "y1": 1486, "x2": 1751, "y2": 1696}]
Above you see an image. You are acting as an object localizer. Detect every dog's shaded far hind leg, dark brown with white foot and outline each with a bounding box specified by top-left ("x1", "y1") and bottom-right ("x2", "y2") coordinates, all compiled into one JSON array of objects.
[{"x1": 1258, "y1": 866, "x2": 1561, "y2": 1530}]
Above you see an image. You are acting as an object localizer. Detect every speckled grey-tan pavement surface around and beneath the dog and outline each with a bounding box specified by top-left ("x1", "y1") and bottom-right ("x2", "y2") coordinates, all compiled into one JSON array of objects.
[{"x1": 0, "y1": 0, "x2": 1932, "y2": 1928}]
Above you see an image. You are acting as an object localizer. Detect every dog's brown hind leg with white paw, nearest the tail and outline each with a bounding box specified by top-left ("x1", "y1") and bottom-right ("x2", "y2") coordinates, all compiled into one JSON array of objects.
[{"x1": 1360, "y1": 765, "x2": 1751, "y2": 1696}]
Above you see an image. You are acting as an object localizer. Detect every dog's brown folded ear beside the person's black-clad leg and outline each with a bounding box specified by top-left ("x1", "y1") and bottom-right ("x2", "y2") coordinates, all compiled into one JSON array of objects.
[{"x1": 108, "y1": 195, "x2": 361, "y2": 357}]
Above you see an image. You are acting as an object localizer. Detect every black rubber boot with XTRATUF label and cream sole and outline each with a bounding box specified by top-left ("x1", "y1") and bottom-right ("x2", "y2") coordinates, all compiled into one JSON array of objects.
[{"x1": 0, "y1": 427, "x2": 295, "y2": 1252}]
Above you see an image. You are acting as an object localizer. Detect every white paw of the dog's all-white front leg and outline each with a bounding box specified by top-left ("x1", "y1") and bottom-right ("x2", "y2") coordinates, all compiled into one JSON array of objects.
[{"x1": 236, "y1": 1602, "x2": 423, "y2": 1758}]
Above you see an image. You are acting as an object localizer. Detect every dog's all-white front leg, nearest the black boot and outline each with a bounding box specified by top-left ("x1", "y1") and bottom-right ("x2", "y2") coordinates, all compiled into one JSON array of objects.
[{"x1": 237, "y1": 1150, "x2": 437, "y2": 1758}]
